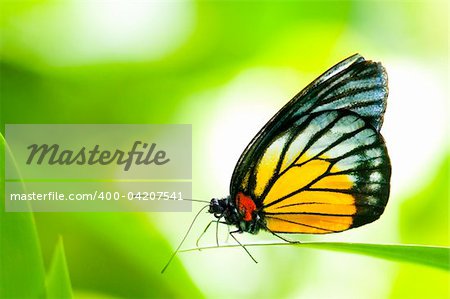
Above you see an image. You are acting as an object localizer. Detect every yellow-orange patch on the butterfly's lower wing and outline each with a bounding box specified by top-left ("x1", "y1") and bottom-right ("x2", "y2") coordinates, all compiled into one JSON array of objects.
[{"x1": 264, "y1": 155, "x2": 357, "y2": 234}]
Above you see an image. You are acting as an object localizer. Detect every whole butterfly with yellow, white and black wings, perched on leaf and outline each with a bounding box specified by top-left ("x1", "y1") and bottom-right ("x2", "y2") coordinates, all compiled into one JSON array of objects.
[{"x1": 162, "y1": 54, "x2": 391, "y2": 274}]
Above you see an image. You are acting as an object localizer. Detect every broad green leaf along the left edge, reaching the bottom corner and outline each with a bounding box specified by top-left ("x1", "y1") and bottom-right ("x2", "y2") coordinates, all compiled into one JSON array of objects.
[{"x1": 0, "y1": 134, "x2": 45, "y2": 298}]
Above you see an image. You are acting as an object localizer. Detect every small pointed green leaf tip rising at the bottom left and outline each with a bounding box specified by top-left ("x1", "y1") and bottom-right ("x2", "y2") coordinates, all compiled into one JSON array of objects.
[{"x1": 47, "y1": 237, "x2": 72, "y2": 299}]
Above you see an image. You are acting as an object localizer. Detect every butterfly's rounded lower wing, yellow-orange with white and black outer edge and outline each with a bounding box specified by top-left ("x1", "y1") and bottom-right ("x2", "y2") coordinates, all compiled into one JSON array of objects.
[{"x1": 260, "y1": 110, "x2": 391, "y2": 234}]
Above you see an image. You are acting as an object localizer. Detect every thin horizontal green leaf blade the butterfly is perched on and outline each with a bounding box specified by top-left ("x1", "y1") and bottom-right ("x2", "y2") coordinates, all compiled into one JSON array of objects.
[{"x1": 180, "y1": 242, "x2": 450, "y2": 271}]
